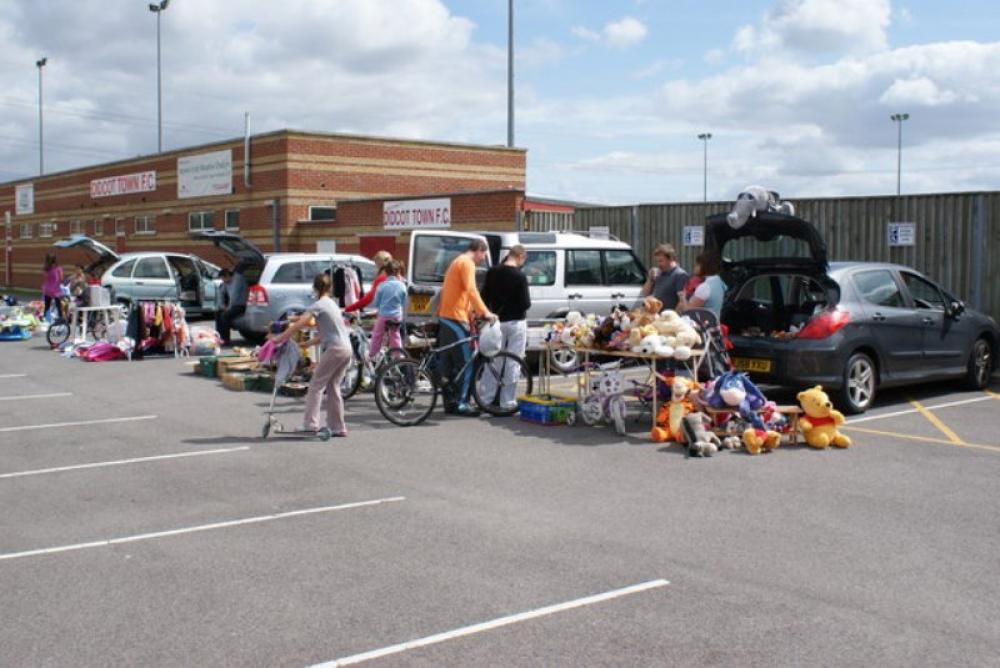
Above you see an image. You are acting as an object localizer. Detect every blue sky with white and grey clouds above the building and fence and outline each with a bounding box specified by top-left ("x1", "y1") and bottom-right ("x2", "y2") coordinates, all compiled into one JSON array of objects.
[{"x1": 0, "y1": 0, "x2": 1000, "y2": 204}]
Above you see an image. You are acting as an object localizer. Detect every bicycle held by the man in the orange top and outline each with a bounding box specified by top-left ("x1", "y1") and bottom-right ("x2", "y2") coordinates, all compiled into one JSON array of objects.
[{"x1": 375, "y1": 323, "x2": 532, "y2": 427}]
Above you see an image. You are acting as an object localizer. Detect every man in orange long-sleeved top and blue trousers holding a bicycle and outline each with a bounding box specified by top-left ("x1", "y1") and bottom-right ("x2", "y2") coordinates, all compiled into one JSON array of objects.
[{"x1": 437, "y1": 239, "x2": 496, "y2": 416}]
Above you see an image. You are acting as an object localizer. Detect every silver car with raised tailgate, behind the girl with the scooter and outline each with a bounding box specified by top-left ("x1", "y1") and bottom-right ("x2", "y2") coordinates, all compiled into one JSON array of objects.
[{"x1": 192, "y1": 231, "x2": 378, "y2": 343}]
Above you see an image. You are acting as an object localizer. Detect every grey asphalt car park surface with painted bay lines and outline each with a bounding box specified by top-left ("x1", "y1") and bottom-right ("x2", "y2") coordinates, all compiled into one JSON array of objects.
[{"x1": 0, "y1": 337, "x2": 1000, "y2": 666}]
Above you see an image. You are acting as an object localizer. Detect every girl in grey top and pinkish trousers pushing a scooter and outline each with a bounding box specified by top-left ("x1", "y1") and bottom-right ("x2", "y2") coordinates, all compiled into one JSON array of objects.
[{"x1": 275, "y1": 274, "x2": 352, "y2": 436}]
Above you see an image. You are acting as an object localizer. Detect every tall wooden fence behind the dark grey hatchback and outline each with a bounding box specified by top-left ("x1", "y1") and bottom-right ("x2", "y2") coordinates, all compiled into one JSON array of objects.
[{"x1": 525, "y1": 192, "x2": 1000, "y2": 320}]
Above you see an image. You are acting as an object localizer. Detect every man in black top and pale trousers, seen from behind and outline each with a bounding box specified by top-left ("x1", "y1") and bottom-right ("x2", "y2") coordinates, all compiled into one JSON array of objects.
[{"x1": 482, "y1": 244, "x2": 531, "y2": 410}]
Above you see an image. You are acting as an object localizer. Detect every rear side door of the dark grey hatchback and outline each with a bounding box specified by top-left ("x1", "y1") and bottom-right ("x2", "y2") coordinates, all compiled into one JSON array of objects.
[{"x1": 851, "y1": 268, "x2": 924, "y2": 379}]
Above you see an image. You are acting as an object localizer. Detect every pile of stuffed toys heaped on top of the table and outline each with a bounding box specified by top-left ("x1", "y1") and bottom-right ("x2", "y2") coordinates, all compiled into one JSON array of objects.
[{"x1": 545, "y1": 297, "x2": 701, "y2": 362}]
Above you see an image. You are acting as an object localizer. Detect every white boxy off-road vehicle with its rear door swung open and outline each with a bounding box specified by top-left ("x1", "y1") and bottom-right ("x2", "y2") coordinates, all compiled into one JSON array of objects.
[{"x1": 408, "y1": 230, "x2": 646, "y2": 325}]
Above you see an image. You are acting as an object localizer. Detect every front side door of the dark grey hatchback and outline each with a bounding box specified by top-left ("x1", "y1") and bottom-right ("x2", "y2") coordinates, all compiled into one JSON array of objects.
[{"x1": 899, "y1": 271, "x2": 973, "y2": 375}]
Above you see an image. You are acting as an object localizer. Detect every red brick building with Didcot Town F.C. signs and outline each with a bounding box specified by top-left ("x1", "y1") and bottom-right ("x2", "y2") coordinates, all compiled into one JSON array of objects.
[{"x1": 0, "y1": 130, "x2": 526, "y2": 288}]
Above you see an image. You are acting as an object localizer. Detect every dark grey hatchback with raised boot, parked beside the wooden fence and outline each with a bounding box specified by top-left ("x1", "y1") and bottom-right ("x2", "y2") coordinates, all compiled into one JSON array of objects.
[{"x1": 705, "y1": 213, "x2": 1000, "y2": 413}]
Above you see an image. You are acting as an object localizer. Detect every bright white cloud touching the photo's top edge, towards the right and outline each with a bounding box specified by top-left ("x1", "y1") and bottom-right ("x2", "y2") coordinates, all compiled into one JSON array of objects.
[{"x1": 733, "y1": 0, "x2": 891, "y2": 55}]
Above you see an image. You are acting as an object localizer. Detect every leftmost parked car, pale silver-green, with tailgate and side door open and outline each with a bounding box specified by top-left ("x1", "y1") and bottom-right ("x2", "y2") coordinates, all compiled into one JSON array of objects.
[{"x1": 53, "y1": 235, "x2": 220, "y2": 316}]
